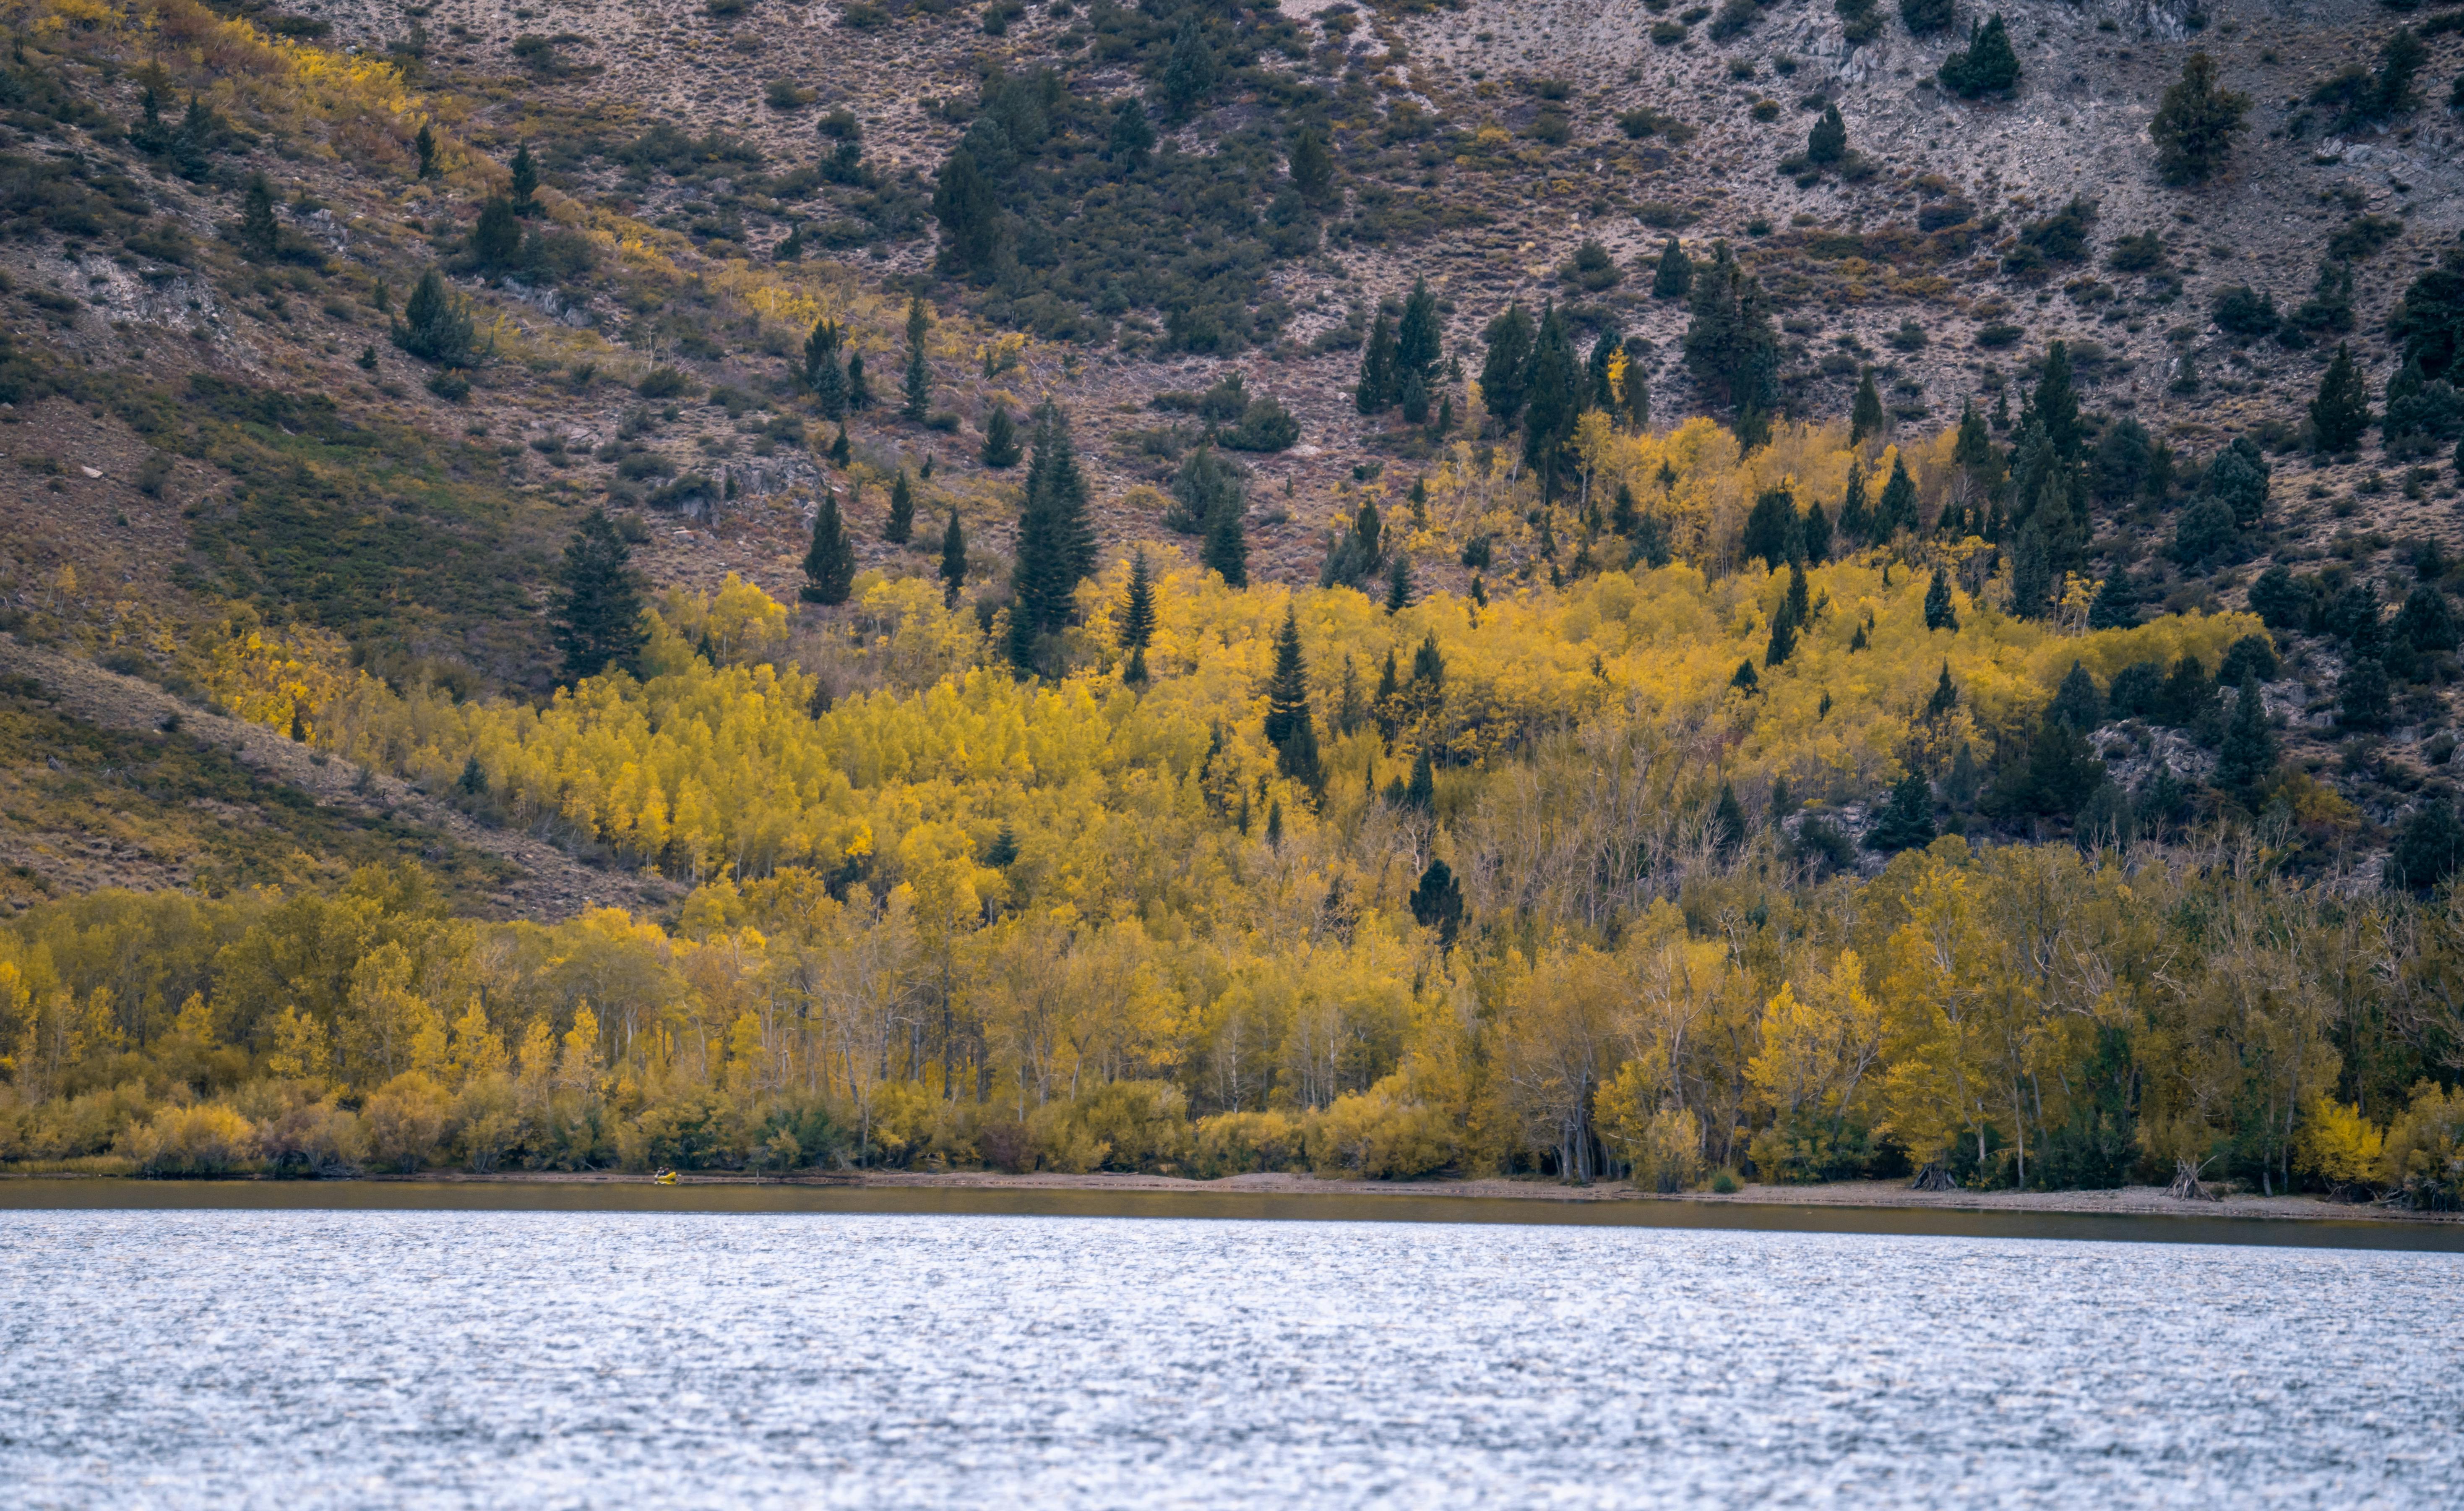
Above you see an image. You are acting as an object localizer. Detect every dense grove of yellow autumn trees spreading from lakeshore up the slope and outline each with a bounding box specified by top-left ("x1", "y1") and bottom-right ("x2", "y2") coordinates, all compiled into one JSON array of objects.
[{"x1": 0, "y1": 407, "x2": 2464, "y2": 1203}]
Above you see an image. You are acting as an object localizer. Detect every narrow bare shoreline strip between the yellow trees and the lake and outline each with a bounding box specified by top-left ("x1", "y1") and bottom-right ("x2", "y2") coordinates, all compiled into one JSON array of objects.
[{"x1": 0, "y1": 1171, "x2": 2464, "y2": 1227}]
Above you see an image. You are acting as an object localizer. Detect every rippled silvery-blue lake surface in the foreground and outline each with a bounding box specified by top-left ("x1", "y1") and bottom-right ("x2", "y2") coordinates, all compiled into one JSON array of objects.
[{"x1": 0, "y1": 1210, "x2": 2464, "y2": 1506}]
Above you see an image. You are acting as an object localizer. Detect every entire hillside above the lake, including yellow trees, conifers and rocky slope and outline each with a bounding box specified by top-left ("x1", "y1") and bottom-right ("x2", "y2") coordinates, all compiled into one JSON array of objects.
[{"x1": 0, "y1": 0, "x2": 2464, "y2": 1203}]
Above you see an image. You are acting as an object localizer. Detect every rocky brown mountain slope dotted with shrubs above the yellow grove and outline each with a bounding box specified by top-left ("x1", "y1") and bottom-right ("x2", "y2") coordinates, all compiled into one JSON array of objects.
[{"x1": 0, "y1": 0, "x2": 2464, "y2": 897}]
